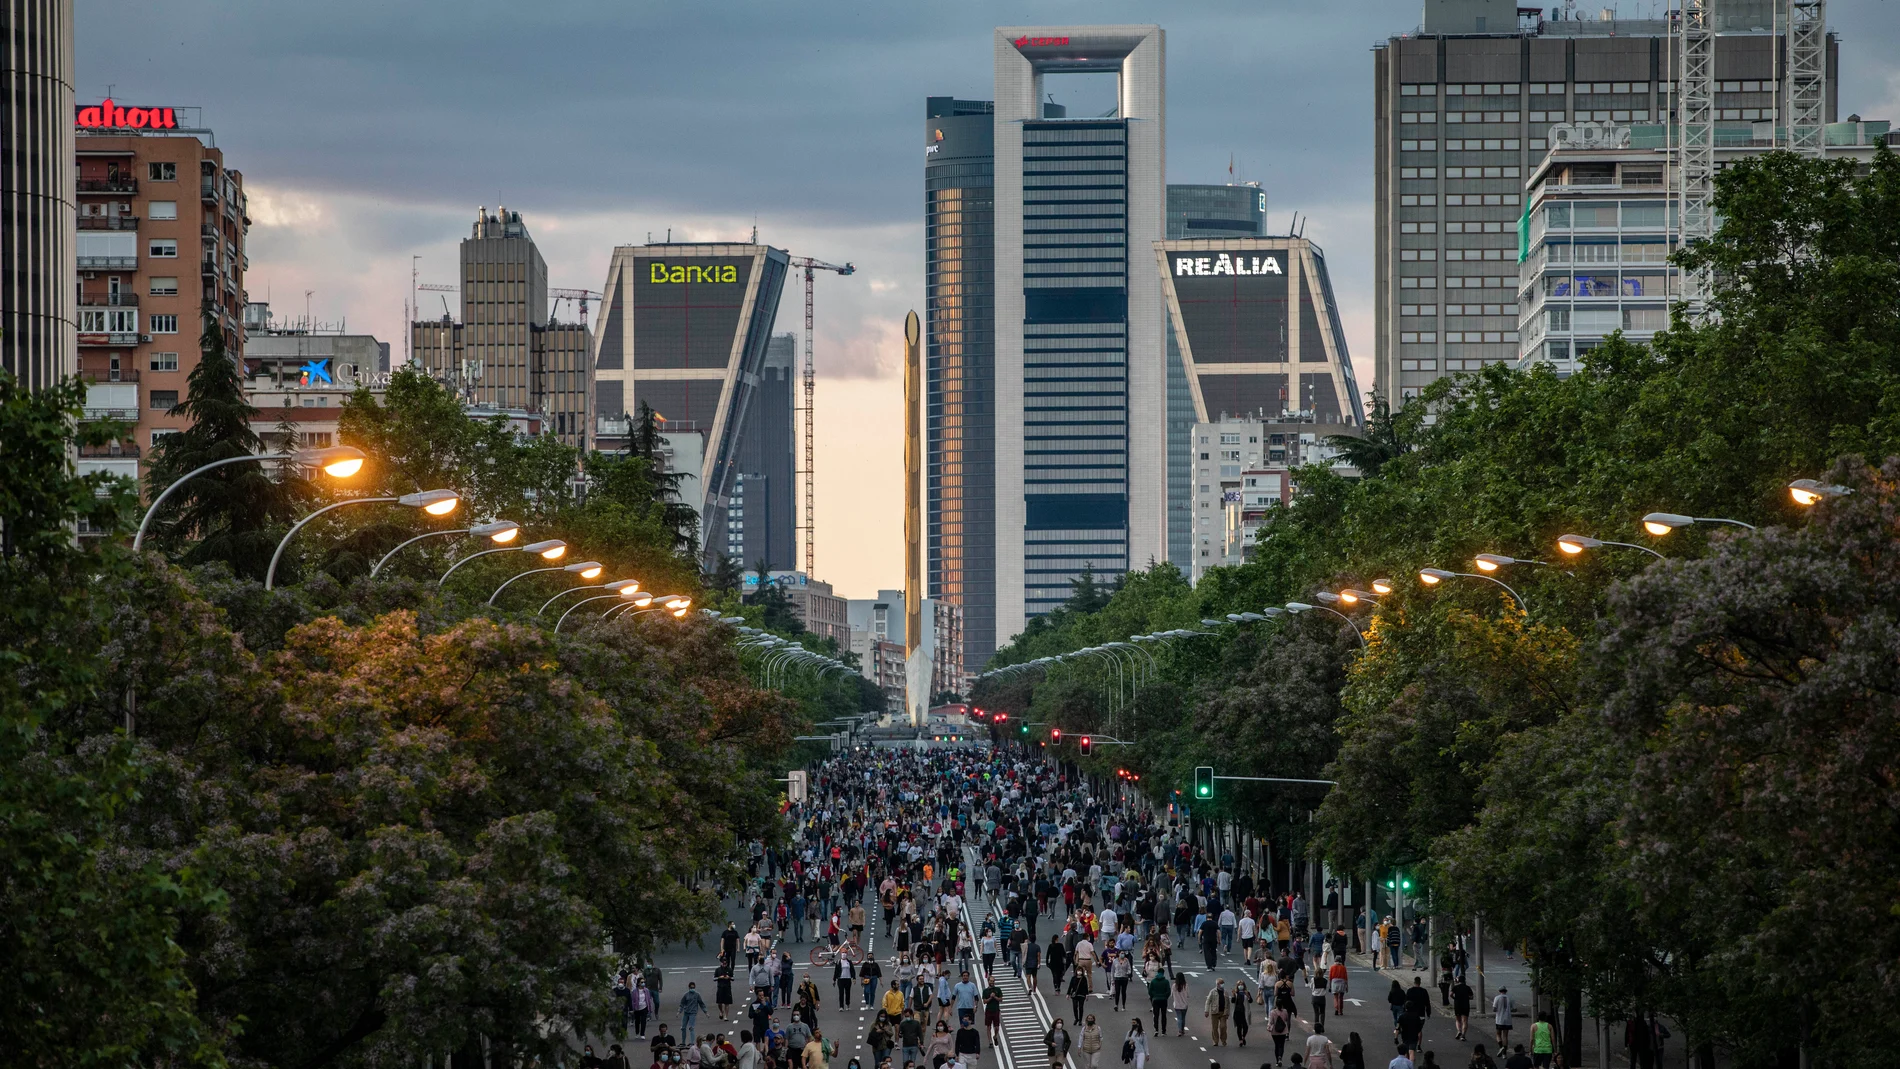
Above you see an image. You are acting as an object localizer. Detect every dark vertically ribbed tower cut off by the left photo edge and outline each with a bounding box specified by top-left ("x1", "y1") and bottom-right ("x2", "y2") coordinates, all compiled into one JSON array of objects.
[{"x1": 0, "y1": 0, "x2": 78, "y2": 389}]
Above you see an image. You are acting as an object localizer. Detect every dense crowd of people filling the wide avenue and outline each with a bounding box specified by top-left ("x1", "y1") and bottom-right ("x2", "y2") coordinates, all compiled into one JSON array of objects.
[{"x1": 589, "y1": 748, "x2": 1562, "y2": 1069}]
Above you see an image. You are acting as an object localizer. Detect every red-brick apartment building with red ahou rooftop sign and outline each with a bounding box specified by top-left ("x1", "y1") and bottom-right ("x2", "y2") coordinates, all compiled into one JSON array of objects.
[{"x1": 67, "y1": 101, "x2": 251, "y2": 477}]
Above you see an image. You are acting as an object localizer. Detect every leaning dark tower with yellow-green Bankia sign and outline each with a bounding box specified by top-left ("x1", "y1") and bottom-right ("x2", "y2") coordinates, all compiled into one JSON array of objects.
[{"x1": 593, "y1": 243, "x2": 786, "y2": 565}]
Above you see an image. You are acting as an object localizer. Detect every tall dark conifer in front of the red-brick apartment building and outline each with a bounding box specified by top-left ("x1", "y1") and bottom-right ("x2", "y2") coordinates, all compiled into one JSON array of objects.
[{"x1": 146, "y1": 311, "x2": 296, "y2": 579}]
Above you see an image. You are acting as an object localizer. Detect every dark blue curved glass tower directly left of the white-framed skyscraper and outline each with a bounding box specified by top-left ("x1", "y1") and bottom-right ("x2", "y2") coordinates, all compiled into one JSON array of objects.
[{"x1": 923, "y1": 97, "x2": 1003, "y2": 670}]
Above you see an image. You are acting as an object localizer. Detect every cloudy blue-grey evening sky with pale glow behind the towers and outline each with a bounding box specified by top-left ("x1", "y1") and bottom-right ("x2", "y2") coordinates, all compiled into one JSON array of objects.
[{"x1": 78, "y1": 0, "x2": 1900, "y2": 596}]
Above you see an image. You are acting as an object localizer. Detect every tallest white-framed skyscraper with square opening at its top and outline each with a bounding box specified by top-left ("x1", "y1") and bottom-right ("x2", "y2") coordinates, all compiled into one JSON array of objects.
[{"x1": 994, "y1": 27, "x2": 1169, "y2": 640}]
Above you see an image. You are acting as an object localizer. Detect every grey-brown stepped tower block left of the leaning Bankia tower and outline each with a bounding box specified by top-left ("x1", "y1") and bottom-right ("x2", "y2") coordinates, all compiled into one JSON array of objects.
[{"x1": 410, "y1": 207, "x2": 593, "y2": 448}]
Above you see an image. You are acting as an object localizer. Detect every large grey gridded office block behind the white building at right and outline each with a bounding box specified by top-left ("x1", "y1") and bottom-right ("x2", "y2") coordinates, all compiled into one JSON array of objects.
[{"x1": 1374, "y1": 0, "x2": 1839, "y2": 406}]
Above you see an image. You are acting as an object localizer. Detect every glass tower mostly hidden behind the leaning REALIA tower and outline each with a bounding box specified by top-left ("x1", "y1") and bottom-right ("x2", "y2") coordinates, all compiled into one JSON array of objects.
[{"x1": 1167, "y1": 184, "x2": 1267, "y2": 573}]
